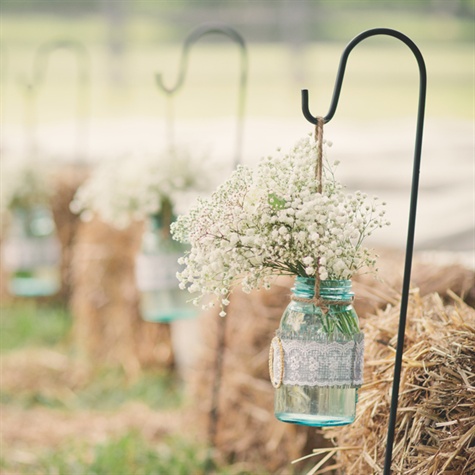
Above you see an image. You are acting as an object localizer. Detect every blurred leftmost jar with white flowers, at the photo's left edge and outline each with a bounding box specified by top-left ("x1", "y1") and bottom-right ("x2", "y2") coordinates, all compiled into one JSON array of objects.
[{"x1": 0, "y1": 156, "x2": 61, "y2": 297}]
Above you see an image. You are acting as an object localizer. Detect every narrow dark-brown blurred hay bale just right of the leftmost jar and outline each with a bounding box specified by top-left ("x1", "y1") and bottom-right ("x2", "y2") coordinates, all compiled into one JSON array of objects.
[{"x1": 51, "y1": 166, "x2": 88, "y2": 300}]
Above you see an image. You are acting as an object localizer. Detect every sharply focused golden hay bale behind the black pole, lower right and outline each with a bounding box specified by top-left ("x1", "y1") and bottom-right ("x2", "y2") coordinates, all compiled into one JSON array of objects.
[{"x1": 326, "y1": 293, "x2": 475, "y2": 475}]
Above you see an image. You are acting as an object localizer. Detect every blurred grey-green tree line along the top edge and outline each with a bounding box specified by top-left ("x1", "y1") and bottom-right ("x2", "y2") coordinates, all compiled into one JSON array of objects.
[{"x1": 0, "y1": 0, "x2": 475, "y2": 45}]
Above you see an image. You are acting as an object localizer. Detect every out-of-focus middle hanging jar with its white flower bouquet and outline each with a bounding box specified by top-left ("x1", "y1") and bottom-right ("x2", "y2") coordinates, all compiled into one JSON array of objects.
[{"x1": 71, "y1": 147, "x2": 220, "y2": 378}]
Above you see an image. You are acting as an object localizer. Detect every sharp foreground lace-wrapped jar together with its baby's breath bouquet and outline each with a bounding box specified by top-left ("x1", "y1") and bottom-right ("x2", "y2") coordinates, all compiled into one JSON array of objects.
[{"x1": 172, "y1": 136, "x2": 389, "y2": 426}]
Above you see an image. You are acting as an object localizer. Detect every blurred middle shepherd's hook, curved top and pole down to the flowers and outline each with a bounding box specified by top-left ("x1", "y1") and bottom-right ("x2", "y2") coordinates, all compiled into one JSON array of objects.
[{"x1": 155, "y1": 23, "x2": 248, "y2": 167}]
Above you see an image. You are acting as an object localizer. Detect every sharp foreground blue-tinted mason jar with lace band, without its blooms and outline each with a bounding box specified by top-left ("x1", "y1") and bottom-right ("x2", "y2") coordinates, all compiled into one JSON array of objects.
[{"x1": 269, "y1": 277, "x2": 364, "y2": 427}]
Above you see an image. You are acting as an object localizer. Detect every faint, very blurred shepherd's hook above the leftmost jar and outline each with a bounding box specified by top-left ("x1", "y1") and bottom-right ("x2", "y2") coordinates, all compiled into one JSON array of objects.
[{"x1": 19, "y1": 39, "x2": 90, "y2": 160}]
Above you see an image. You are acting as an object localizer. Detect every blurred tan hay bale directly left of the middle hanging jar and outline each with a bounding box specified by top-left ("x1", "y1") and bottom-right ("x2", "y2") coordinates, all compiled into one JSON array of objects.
[{"x1": 71, "y1": 219, "x2": 173, "y2": 375}]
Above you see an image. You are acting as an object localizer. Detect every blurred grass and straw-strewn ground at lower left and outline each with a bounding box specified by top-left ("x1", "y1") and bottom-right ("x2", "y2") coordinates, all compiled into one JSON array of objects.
[{"x1": 0, "y1": 301, "x2": 260, "y2": 475}]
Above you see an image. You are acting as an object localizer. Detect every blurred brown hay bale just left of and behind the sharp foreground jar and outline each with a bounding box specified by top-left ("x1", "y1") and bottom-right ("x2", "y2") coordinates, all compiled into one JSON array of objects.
[{"x1": 192, "y1": 278, "x2": 328, "y2": 474}]
